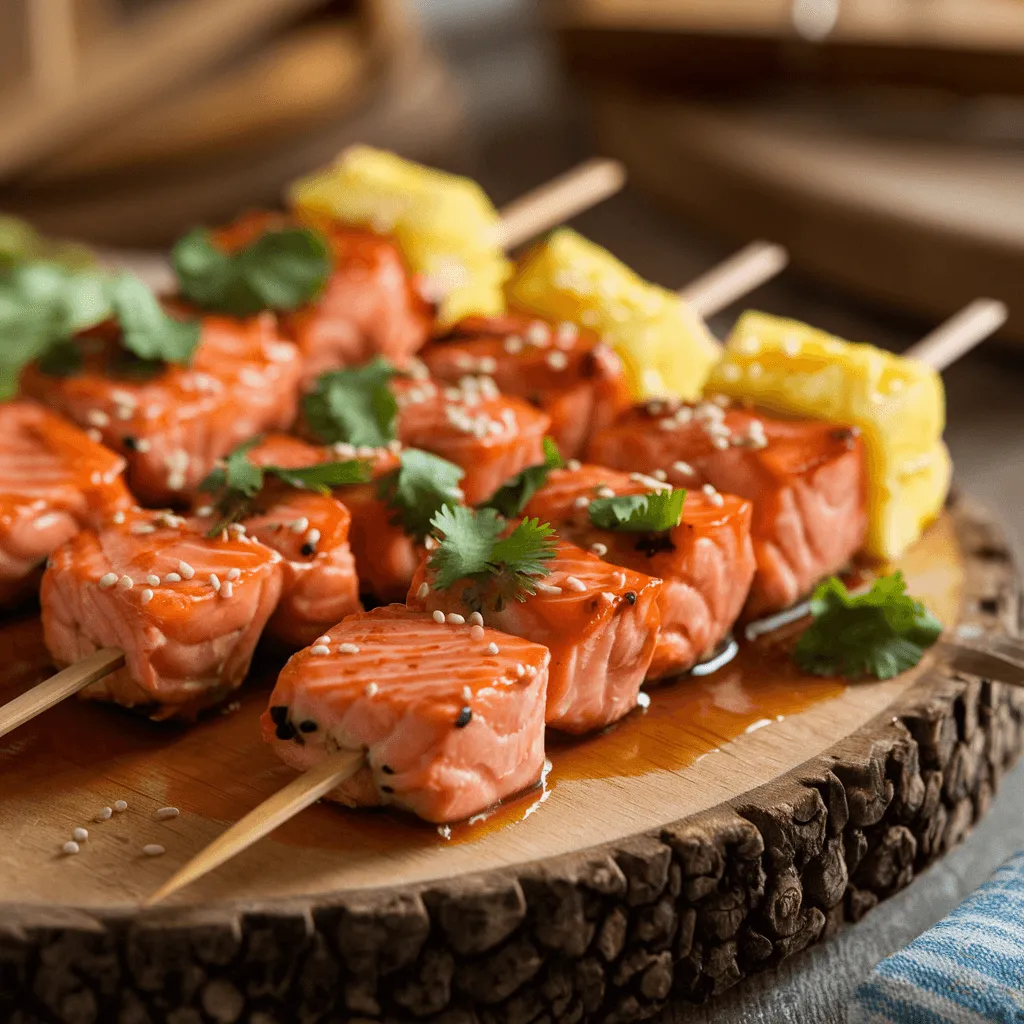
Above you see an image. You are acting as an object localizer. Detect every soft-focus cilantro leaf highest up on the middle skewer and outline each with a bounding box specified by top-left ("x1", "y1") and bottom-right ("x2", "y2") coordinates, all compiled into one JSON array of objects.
[{"x1": 303, "y1": 356, "x2": 398, "y2": 447}]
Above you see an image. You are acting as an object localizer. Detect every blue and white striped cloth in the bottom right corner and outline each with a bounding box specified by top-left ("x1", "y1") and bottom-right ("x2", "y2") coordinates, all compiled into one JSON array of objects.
[{"x1": 849, "y1": 851, "x2": 1024, "y2": 1024}]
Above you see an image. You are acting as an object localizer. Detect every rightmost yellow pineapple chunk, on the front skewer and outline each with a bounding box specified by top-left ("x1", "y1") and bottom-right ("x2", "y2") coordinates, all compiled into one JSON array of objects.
[{"x1": 708, "y1": 312, "x2": 951, "y2": 559}]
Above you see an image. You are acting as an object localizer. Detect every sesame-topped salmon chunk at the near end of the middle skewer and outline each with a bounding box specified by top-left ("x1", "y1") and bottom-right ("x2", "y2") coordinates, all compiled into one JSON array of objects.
[{"x1": 41, "y1": 509, "x2": 281, "y2": 719}]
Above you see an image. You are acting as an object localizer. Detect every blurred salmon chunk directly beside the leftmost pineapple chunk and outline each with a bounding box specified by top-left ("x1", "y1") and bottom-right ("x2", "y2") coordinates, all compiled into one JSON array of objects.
[{"x1": 214, "y1": 211, "x2": 433, "y2": 384}]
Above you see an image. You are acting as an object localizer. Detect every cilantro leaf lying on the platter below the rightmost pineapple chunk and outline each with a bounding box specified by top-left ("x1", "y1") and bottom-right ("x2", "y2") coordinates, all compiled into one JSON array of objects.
[{"x1": 794, "y1": 571, "x2": 942, "y2": 679}]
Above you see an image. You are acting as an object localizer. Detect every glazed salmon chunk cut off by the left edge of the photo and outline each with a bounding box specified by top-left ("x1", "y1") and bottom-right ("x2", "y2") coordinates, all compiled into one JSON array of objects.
[{"x1": 0, "y1": 401, "x2": 134, "y2": 605}]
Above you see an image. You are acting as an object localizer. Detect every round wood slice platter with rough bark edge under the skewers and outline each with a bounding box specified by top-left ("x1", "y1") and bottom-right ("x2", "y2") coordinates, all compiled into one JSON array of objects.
[{"x1": 0, "y1": 491, "x2": 1024, "y2": 1024}]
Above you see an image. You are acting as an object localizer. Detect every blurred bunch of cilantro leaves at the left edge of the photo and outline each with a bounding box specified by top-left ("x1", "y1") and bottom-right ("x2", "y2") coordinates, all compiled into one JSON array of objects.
[{"x1": 0, "y1": 262, "x2": 199, "y2": 398}]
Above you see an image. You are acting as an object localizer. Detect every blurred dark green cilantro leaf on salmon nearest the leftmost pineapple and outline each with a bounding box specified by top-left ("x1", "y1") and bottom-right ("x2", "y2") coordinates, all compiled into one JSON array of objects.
[{"x1": 172, "y1": 227, "x2": 332, "y2": 316}]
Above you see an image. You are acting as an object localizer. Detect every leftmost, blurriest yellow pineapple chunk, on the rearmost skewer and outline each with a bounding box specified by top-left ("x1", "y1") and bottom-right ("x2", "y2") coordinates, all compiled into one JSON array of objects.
[{"x1": 288, "y1": 145, "x2": 512, "y2": 327}]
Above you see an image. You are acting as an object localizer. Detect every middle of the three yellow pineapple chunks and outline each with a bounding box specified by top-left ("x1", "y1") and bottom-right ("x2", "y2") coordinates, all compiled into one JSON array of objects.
[{"x1": 508, "y1": 227, "x2": 720, "y2": 399}]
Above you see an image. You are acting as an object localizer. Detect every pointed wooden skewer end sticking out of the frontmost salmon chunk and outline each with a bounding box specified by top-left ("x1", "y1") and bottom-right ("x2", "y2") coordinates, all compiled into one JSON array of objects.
[{"x1": 142, "y1": 751, "x2": 366, "y2": 906}]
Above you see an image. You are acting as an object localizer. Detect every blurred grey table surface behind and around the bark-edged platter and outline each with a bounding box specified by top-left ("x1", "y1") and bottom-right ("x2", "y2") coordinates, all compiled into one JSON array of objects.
[{"x1": 411, "y1": 0, "x2": 1024, "y2": 1024}]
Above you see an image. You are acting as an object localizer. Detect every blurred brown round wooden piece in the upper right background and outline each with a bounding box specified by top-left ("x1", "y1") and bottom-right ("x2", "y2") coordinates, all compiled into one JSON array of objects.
[{"x1": 581, "y1": 91, "x2": 1024, "y2": 343}]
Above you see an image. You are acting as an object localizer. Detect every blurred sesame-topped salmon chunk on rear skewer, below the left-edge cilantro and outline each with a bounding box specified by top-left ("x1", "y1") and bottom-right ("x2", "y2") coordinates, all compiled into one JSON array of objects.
[{"x1": 22, "y1": 313, "x2": 301, "y2": 505}]
